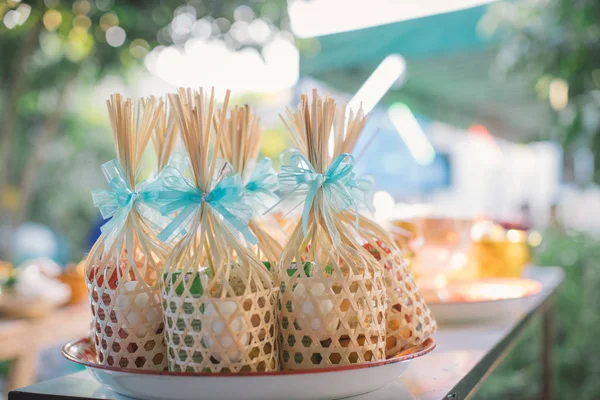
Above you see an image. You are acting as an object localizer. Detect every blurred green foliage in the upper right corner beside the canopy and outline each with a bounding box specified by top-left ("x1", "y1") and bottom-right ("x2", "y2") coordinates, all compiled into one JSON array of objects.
[{"x1": 486, "y1": 0, "x2": 600, "y2": 180}]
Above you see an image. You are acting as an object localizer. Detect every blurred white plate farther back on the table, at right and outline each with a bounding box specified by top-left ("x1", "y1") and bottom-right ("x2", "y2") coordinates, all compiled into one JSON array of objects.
[{"x1": 423, "y1": 278, "x2": 542, "y2": 324}]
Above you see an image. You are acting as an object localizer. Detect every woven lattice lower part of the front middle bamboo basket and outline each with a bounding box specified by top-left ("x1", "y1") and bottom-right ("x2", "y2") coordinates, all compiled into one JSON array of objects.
[{"x1": 163, "y1": 266, "x2": 278, "y2": 372}]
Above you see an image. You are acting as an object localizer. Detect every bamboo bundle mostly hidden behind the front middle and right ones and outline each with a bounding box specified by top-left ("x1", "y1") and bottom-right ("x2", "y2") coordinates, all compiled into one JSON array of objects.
[{"x1": 220, "y1": 105, "x2": 282, "y2": 266}]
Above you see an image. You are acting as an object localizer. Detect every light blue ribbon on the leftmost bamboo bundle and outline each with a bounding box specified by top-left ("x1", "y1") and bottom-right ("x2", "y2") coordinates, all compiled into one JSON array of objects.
[{"x1": 92, "y1": 160, "x2": 164, "y2": 250}]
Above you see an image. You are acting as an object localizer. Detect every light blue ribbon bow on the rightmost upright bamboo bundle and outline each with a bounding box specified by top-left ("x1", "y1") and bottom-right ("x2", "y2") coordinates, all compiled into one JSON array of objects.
[{"x1": 278, "y1": 150, "x2": 370, "y2": 244}]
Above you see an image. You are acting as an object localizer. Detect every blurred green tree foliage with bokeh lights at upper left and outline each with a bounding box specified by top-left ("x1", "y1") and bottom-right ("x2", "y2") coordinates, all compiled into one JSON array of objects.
[{"x1": 0, "y1": 0, "x2": 289, "y2": 260}]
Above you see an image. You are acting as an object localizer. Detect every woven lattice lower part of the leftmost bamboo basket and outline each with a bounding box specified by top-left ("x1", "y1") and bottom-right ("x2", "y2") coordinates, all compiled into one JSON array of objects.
[{"x1": 88, "y1": 241, "x2": 167, "y2": 371}]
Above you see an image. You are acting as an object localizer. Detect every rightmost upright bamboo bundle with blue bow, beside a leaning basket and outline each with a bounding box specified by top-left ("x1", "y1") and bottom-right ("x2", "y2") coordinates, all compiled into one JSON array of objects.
[{"x1": 278, "y1": 90, "x2": 386, "y2": 370}]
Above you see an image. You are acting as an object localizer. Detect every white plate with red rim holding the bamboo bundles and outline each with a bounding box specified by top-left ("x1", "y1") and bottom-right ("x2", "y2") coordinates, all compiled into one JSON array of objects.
[{"x1": 62, "y1": 338, "x2": 435, "y2": 400}]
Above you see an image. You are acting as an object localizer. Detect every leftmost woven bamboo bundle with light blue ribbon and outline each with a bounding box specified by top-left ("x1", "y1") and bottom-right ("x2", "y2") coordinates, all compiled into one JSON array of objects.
[{"x1": 86, "y1": 94, "x2": 167, "y2": 371}]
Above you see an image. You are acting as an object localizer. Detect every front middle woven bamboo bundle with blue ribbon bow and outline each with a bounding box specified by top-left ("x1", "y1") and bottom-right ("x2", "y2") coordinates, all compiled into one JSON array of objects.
[{"x1": 159, "y1": 89, "x2": 278, "y2": 372}]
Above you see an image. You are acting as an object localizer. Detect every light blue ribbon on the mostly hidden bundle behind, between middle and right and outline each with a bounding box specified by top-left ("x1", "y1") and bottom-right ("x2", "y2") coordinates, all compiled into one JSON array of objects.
[{"x1": 243, "y1": 157, "x2": 279, "y2": 214}]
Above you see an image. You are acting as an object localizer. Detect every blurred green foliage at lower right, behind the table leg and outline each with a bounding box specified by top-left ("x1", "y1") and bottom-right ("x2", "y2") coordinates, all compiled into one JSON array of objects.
[{"x1": 476, "y1": 228, "x2": 600, "y2": 400}]
